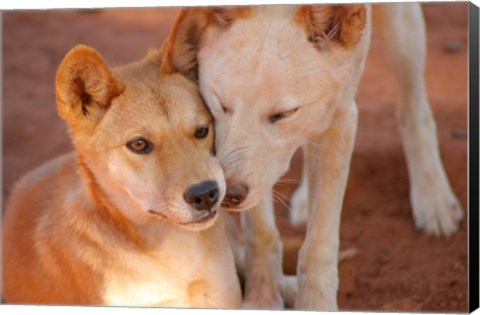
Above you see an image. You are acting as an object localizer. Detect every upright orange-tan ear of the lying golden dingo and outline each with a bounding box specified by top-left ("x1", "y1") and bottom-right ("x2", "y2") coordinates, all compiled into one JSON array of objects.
[{"x1": 55, "y1": 45, "x2": 125, "y2": 128}]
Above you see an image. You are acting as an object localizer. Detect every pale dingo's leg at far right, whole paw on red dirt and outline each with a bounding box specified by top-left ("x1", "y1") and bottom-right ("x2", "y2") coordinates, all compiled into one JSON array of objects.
[{"x1": 373, "y1": 3, "x2": 463, "y2": 235}]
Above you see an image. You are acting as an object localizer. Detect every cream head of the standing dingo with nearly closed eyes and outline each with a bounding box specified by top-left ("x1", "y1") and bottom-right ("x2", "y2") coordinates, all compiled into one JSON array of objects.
[{"x1": 163, "y1": 5, "x2": 369, "y2": 210}]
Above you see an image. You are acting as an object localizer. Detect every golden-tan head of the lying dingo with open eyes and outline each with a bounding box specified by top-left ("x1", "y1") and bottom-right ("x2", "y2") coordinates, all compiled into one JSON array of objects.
[{"x1": 56, "y1": 46, "x2": 226, "y2": 230}]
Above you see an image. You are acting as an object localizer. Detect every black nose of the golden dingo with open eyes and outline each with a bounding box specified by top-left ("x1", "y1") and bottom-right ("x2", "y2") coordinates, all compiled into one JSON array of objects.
[{"x1": 183, "y1": 181, "x2": 220, "y2": 210}]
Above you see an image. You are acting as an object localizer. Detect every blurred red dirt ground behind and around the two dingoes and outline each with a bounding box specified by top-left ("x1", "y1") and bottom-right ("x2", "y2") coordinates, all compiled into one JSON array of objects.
[{"x1": 2, "y1": 3, "x2": 468, "y2": 312}]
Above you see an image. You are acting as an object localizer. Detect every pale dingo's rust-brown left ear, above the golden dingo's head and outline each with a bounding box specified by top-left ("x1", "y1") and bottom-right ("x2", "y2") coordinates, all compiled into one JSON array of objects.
[{"x1": 161, "y1": 7, "x2": 249, "y2": 81}]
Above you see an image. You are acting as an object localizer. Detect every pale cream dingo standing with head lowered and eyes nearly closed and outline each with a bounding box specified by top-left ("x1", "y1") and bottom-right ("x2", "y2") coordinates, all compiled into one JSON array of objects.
[{"x1": 164, "y1": 3, "x2": 463, "y2": 310}]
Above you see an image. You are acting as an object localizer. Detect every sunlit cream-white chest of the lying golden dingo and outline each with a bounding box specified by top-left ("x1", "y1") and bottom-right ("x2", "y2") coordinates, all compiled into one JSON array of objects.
[{"x1": 103, "y1": 227, "x2": 238, "y2": 307}]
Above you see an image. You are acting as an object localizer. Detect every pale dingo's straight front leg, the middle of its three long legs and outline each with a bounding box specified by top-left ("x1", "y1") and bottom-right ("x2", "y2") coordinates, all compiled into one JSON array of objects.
[{"x1": 295, "y1": 102, "x2": 357, "y2": 311}]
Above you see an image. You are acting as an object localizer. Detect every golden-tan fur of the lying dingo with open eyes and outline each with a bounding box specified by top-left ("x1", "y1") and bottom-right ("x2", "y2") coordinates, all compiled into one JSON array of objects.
[{"x1": 3, "y1": 46, "x2": 241, "y2": 308}]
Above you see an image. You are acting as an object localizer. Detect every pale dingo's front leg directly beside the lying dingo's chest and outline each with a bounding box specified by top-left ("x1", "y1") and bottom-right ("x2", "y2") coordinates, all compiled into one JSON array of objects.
[{"x1": 242, "y1": 191, "x2": 284, "y2": 309}]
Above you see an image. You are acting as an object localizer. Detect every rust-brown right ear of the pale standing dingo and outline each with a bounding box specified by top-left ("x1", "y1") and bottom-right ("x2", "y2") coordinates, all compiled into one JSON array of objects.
[{"x1": 295, "y1": 4, "x2": 367, "y2": 50}]
